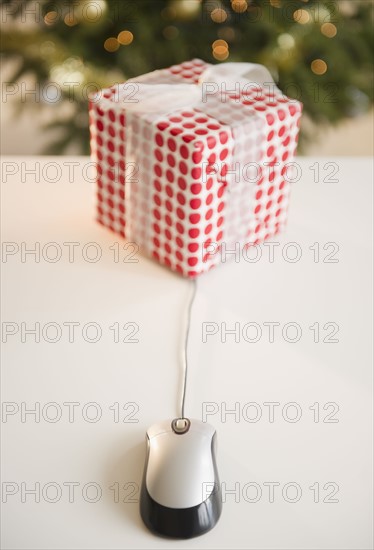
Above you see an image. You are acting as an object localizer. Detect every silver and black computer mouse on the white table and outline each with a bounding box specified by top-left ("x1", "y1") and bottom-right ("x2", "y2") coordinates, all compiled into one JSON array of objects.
[{"x1": 140, "y1": 418, "x2": 222, "y2": 539}]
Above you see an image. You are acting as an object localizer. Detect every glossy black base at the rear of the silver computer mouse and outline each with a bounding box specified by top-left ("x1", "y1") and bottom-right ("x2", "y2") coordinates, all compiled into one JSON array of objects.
[{"x1": 140, "y1": 483, "x2": 222, "y2": 539}]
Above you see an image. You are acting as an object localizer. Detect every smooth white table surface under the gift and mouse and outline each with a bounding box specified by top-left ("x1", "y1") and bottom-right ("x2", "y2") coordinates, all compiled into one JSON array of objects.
[{"x1": 2, "y1": 157, "x2": 373, "y2": 550}]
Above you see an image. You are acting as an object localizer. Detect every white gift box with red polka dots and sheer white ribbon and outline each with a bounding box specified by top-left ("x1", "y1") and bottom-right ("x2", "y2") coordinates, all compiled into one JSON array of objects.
[{"x1": 90, "y1": 59, "x2": 302, "y2": 277}]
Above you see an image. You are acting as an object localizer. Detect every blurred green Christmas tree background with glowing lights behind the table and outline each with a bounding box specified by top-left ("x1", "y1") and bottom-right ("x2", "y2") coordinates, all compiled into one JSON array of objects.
[{"x1": 1, "y1": 0, "x2": 373, "y2": 156}]
